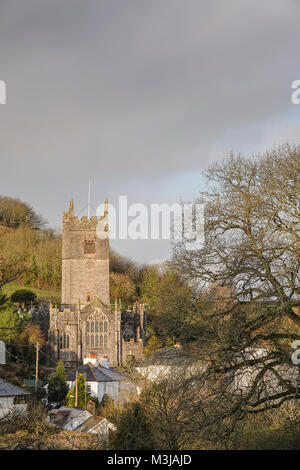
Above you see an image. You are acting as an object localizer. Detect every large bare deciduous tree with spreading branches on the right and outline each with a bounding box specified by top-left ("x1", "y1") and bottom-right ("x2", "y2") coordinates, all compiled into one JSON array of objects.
[{"x1": 173, "y1": 145, "x2": 300, "y2": 432}]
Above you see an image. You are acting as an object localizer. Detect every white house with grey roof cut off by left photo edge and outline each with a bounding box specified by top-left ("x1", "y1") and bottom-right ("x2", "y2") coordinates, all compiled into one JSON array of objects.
[{"x1": 0, "y1": 379, "x2": 30, "y2": 419}]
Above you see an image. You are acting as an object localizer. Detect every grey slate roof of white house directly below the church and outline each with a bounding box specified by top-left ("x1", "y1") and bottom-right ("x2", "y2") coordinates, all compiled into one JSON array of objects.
[{"x1": 67, "y1": 362, "x2": 128, "y2": 382}]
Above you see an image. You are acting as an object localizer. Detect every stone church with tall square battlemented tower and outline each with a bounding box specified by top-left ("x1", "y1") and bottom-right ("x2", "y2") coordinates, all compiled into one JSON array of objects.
[{"x1": 48, "y1": 201, "x2": 146, "y2": 367}]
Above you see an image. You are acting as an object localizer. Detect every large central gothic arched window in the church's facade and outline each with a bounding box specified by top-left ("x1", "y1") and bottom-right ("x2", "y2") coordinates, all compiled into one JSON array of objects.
[{"x1": 85, "y1": 311, "x2": 108, "y2": 348}]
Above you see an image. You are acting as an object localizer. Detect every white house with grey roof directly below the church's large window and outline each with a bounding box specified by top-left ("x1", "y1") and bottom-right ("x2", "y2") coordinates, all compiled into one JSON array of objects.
[{"x1": 66, "y1": 356, "x2": 137, "y2": 404}]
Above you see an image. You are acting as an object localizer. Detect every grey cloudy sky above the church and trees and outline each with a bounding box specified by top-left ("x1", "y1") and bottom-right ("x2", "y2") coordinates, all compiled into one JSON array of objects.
[{"x1": 0, "y1": 0, "x2": 300, "y2": 262}]
